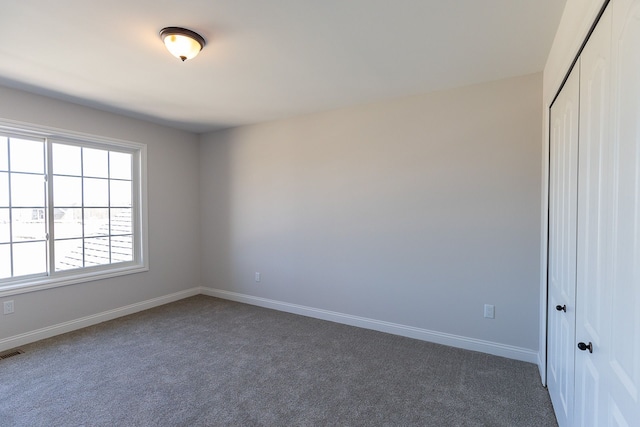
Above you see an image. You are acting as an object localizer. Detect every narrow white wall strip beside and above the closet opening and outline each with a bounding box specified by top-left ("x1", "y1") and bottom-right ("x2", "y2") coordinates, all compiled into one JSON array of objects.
[{"x1": 538, "y1": 0, "x2": 606, "y2": 384}]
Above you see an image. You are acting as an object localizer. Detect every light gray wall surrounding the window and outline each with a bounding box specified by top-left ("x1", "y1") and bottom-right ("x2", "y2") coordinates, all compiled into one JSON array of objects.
[{"x1": 0, "y1": 87, "x2": 200, "y2": 350}]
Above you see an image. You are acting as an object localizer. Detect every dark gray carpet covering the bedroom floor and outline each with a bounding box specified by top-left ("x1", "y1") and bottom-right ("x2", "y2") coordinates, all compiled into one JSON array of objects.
[{"x1": 0, "y1": 295, "x2": 556, "y2": 427}]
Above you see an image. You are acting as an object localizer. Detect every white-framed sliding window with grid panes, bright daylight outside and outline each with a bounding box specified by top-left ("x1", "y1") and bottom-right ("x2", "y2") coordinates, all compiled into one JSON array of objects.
[{"x1": 0, "y1": 120, "x2": 147, "y2": 291}]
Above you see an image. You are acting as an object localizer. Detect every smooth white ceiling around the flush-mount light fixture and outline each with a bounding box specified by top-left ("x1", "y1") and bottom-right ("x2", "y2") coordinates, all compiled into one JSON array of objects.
[{"x1": 0, "y1": 0, "x2": 565, "y2": 133}]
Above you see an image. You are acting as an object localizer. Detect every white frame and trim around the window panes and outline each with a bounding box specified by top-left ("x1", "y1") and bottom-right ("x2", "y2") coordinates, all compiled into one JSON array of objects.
[{"x1": 0, "y1": 119, "x2": 149, "y2": 298}]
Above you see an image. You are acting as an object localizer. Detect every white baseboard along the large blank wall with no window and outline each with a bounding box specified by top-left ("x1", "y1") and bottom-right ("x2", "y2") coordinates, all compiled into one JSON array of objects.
[{"x1": 201, "y1": 287, "x2": 539, "y2": 364}]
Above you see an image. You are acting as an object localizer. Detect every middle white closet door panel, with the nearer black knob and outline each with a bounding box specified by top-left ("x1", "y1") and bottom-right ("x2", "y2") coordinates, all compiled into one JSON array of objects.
[{"x1": 572, "y1": 7, "x2": 613, "y2": 426}]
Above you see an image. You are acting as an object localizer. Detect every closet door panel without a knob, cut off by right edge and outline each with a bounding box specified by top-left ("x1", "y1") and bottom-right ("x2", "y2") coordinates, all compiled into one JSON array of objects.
[{"x1": 594, "y1": 0, "x2": 640, "y2": 426}]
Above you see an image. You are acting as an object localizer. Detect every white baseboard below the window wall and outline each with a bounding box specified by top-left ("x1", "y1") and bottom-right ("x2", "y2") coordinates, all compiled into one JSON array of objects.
[{"x1": 0, "y1": 287, "x2": 202, "y2": 351}]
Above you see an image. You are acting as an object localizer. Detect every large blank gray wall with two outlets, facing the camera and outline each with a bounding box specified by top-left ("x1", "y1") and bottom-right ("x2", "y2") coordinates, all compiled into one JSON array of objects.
[{"x1": 200, "y1": 74, "x2": 542, "y2": 361}]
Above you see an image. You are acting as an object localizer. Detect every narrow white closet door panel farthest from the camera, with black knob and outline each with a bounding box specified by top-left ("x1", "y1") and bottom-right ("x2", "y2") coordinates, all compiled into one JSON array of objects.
[{"x1": 547, "y1": 63, "x2": 580, "y2": 426}]
